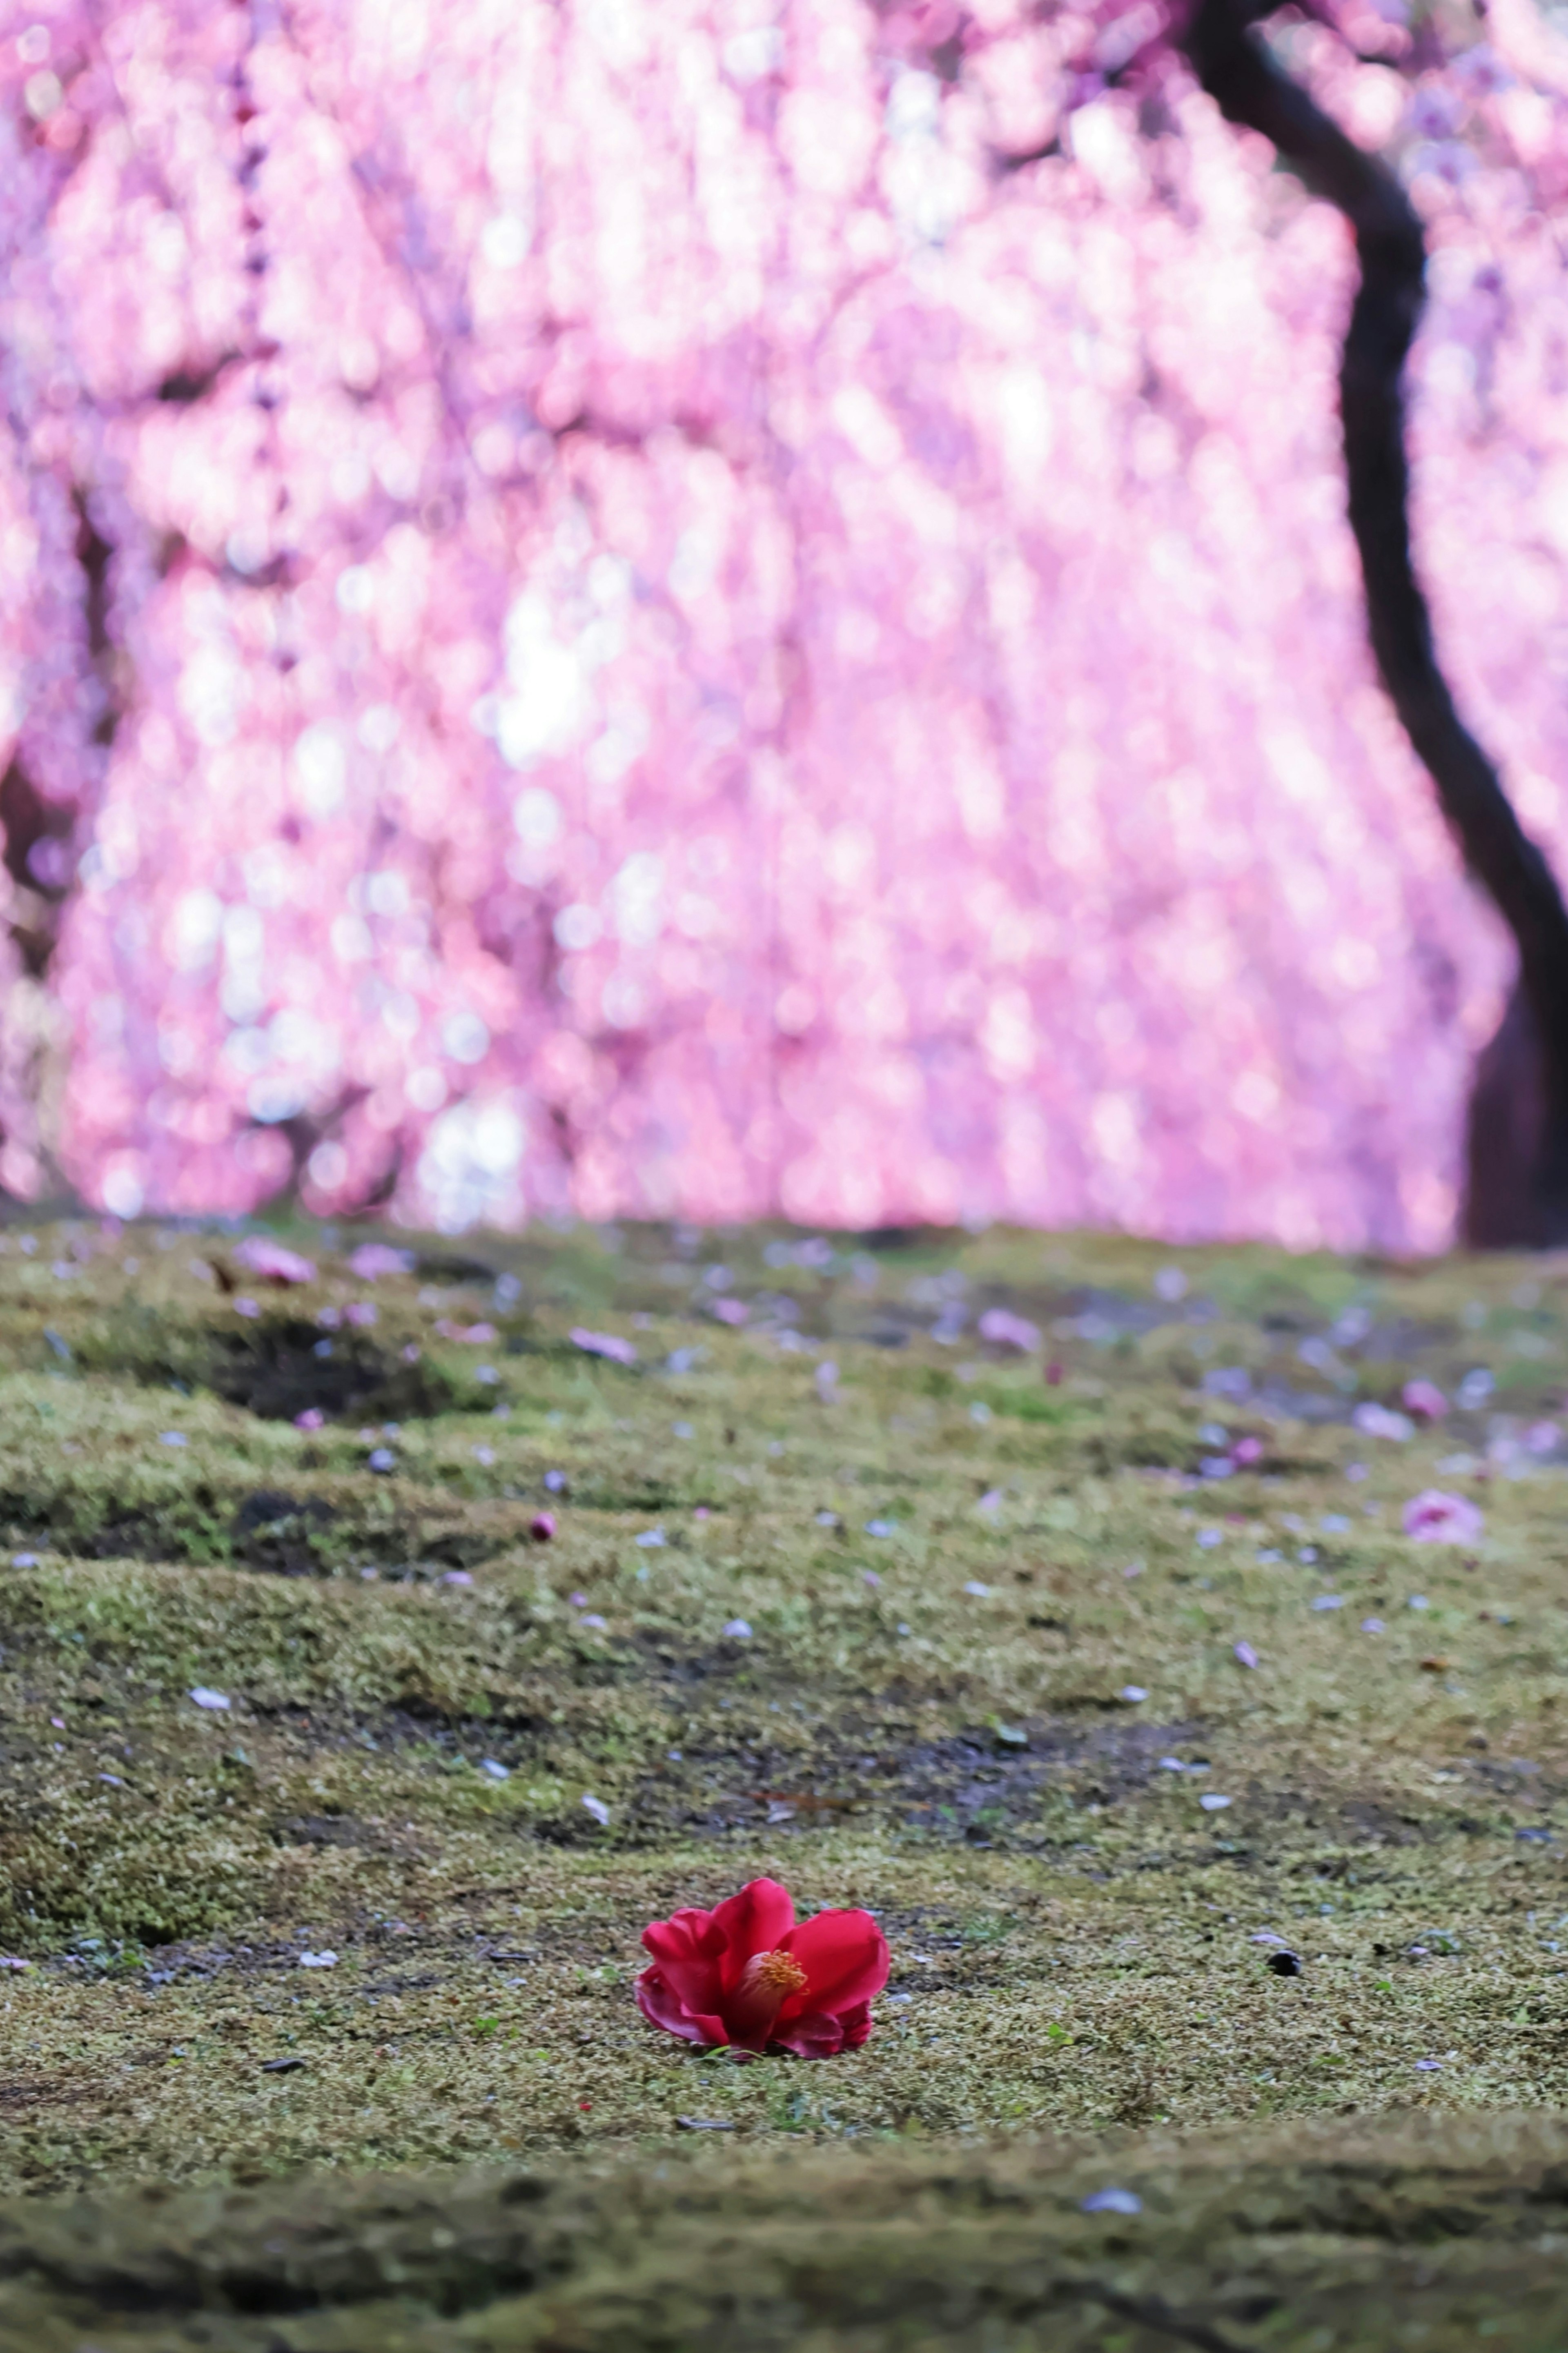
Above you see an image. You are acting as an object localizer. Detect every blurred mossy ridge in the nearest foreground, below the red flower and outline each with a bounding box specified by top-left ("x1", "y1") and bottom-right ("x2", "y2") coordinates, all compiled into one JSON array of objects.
[{"x1": 0, "y1": 2118, "x2": 1568, "y2": 2353}]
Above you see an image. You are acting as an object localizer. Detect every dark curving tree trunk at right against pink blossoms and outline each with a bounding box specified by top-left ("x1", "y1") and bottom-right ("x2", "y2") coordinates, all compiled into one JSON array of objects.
[{"x1": 1182, "y1": 0, "x2": 1568, "y2": 1247}]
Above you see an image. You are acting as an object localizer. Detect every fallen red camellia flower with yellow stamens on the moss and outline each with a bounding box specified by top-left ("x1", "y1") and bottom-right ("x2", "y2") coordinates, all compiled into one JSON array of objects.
[{"x1": 638, "y1": 1880, "x2": 888, "y2": 2059}]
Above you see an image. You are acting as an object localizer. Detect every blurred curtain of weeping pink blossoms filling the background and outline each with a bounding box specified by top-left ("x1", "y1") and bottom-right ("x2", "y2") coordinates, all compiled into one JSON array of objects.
[{"x1": 0, "y1": 0, "x2": 1568, "y2": 1247}]
